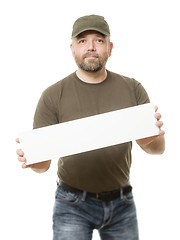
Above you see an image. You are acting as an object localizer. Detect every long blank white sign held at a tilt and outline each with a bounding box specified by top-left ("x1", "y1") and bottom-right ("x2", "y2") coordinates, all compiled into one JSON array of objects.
[{"x1": 19, "y1": 103, "x2": 159, "y2": 165}]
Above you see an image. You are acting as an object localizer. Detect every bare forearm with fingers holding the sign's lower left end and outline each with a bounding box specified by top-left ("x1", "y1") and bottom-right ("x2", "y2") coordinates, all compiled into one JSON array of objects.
[{"x1": 16, "y1": 138, "x2": 51, "y2": 173}]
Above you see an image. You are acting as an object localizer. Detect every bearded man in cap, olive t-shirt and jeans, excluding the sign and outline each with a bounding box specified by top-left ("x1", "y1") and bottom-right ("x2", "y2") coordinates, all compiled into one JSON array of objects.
[{"x1": 17, "y1": 15, "x2": 165, "y2": 240}]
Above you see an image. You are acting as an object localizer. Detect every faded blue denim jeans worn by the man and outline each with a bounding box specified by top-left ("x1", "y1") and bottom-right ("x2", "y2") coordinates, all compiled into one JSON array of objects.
[{"x1": 53, "y1": 186, "x2": 139, "y2": 240}]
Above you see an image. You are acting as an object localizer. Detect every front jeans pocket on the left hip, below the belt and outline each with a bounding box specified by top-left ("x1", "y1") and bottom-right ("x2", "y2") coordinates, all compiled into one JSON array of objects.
[{"x1": 55, "y1": 186, "x2": 82, "y2": 205}]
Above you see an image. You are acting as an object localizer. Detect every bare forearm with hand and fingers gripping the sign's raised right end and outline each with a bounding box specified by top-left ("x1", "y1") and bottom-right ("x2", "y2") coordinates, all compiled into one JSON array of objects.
[{"x1": 136, "y1": 106, "x2": 165, "y2": 154}]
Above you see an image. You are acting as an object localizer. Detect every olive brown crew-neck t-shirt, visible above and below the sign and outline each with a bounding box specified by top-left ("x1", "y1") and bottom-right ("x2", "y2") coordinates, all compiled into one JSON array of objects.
[{"x1": 33, "y1": 71, "x2": 149, "y2": 193}]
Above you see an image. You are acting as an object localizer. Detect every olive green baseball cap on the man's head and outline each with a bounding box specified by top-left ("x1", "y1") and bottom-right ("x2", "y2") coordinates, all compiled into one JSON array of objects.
[{"x1": 72, "y1": 15, "x2": 110, "y2": 38}]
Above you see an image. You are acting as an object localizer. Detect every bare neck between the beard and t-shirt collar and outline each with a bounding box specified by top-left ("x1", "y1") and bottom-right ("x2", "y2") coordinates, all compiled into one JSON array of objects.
[{"x1": 76, "y1": 68, "x2": 107, "y2": 84}]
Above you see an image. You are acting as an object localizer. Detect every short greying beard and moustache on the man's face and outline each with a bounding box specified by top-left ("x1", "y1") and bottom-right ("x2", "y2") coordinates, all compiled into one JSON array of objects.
[{"x1": 75, "y1": 52, "x2": 108, "y2": 72}]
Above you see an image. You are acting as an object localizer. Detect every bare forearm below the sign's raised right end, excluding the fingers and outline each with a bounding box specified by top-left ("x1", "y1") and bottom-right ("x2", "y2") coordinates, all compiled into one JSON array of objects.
[{"x1": 137, "y1": 135, "x2": 165, "y2": 154}]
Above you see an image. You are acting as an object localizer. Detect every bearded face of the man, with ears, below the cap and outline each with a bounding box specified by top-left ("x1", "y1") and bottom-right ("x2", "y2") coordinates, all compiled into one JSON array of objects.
[{"x1": 71, "y1": 31, "x2": 112, "y2": 72}]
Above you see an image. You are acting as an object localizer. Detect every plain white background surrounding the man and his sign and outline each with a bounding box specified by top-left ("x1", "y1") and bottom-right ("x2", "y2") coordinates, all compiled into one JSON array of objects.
[{"x1": 0, "y1": 0, "x2": 180, "y2": 240}]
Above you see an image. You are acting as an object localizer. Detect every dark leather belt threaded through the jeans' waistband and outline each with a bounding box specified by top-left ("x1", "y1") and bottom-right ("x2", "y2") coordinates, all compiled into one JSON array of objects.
[{"x1": 59, "y1": 182, "x2": 132, "y2": 201}]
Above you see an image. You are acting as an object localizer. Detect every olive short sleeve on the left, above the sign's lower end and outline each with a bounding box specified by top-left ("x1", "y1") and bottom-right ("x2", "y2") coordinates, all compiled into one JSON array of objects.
[{"x1": 33, "y1": 91, "x2": 58, "y2": 129}]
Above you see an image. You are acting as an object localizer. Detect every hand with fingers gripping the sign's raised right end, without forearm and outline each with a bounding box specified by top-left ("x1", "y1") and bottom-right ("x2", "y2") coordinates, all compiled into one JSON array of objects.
[{"x1": 136, "y1": 106, "x2": 165, "y2": 147}]
